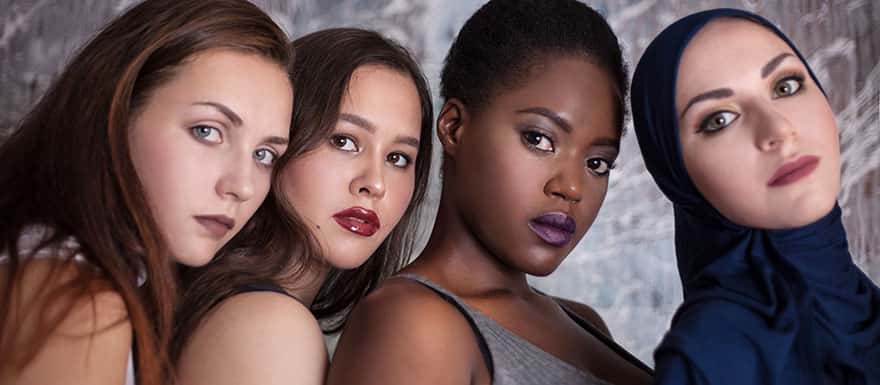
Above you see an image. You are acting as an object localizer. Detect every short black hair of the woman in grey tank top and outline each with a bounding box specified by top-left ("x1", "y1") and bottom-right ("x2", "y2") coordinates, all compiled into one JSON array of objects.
[{"x1": 440, "y1": 0, "x2": 628, "y2": 132}]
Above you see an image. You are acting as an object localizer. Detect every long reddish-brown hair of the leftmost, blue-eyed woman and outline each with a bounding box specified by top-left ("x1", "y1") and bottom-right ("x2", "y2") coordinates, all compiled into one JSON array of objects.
[{"x1": 0, "y1": 0, "x2": 292, "y2": 384}]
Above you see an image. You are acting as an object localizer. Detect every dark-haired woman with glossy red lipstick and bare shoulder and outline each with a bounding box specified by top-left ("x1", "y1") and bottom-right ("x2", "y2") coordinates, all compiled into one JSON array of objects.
[{"x1": 172, "y1": 28, "x2": 433, "y2": 385}]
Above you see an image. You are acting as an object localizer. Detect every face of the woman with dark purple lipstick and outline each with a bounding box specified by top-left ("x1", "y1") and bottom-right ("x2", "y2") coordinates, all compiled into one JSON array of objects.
[{"x1": 439, "y1": 56, "x2": 620, "y2": 276}]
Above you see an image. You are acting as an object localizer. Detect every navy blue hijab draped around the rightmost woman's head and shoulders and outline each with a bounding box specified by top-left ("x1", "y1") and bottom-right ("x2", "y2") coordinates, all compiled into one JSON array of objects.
[{"x1": 632, "y1": 9, "x2": 880, "y2": 385}]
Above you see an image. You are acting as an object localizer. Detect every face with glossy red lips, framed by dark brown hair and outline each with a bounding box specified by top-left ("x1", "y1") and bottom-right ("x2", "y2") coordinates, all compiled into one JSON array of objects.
[{"x1": 281, "y1": 65, "x2": 422, "y2": 269}]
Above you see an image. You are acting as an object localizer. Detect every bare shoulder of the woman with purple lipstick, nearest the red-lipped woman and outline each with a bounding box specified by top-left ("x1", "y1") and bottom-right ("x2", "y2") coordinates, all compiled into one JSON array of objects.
[{"x1": 328, "y1": 278, "x2": 483, "y2": 384}]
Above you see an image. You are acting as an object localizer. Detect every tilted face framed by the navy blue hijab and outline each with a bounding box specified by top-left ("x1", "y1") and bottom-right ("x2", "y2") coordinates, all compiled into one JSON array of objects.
[{"x1": 675, "y1": 18, "x2": 840, "y2": 229}]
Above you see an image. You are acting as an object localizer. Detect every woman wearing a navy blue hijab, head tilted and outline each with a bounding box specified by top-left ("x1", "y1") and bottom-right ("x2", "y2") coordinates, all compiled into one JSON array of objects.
[{"x1": 632, "y1": 9, "x2": 880, "y2": 385}]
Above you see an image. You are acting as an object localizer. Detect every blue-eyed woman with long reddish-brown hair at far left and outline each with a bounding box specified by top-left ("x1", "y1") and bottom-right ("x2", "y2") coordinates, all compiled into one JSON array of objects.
[{"x1": 0, "y1": 0, "x2": 293, "y2": 385}]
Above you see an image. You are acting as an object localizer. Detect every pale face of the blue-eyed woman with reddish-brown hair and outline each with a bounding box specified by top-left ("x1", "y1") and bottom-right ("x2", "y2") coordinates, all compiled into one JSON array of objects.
[{"x1": 128, "y1": 50, "x2": 293, "y2": 266}]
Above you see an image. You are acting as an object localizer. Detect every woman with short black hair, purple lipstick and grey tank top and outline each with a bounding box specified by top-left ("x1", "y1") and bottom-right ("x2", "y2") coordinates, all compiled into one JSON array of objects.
[{"x1": 328, "y1": 0, "x2": 651, "y2": 385}]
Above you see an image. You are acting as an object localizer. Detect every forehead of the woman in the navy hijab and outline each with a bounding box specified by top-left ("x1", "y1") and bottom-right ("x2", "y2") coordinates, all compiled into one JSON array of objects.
[{"x1": 677, "y1": 17, "x2": 794, "y2": 89}]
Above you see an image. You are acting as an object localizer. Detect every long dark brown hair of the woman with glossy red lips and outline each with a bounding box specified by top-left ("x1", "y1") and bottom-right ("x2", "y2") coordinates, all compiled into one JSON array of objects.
[{"x1": 172, "y1": 28, "x2": 433, "y2": 359}]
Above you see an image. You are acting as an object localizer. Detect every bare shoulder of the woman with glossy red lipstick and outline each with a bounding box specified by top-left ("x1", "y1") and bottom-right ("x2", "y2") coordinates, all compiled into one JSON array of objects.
[{"x1": 177, "y1": 292, "x2": 327, "y2": 384}]
